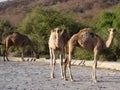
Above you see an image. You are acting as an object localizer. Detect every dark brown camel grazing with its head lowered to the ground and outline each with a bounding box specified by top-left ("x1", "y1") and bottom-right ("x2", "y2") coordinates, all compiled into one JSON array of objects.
[{"x1": 3, "y1": 32, "x2": 39, "y2": 61}]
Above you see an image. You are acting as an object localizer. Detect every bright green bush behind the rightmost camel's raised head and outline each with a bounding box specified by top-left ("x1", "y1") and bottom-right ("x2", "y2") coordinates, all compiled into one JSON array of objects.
[{"x1": 96, "y1": 4, "x2": 120, "y2": 59}]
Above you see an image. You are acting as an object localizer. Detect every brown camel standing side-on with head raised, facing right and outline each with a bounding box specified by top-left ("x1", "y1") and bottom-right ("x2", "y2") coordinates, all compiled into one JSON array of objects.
[{"x1": 64, "y1": 28, "x2": 116, "y2": 82}]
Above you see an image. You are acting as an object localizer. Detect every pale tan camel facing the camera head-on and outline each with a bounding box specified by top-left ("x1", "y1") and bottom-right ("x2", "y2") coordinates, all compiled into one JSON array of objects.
[{"x1": 48, "y1": 28, "x2": 69, "y2": 78}]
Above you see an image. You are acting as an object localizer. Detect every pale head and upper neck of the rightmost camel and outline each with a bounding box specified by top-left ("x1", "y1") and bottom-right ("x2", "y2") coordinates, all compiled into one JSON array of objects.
[{"x1": 105, "y1": 28, "x2": 116, "y2": 48}]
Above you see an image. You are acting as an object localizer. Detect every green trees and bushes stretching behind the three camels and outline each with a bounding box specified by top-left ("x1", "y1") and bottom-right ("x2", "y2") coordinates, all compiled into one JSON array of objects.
[{"x1": 0, "y1": 2, "x2": 120, "y2": 61}]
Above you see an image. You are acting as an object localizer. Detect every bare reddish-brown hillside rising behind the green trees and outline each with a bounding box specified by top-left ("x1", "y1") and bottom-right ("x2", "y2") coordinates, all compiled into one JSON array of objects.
[{"x1": 0, "y1": 0, "x2": 120, "y2": 25}]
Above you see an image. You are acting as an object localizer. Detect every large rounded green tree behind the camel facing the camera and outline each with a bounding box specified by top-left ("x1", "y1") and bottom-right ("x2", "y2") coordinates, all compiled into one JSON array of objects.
[{"x1": 17, "y1": 7, "x2": 84, "y2": 54}]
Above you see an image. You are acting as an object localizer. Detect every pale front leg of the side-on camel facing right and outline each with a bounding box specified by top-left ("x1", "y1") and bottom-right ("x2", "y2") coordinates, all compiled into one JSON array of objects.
[{"x1": 92, "y1": 48, "x2": 98, "y2": 83}]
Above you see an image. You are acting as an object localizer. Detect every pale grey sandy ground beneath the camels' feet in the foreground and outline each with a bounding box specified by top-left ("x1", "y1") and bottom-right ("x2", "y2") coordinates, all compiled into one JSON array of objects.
[{"x1": 0, "y1": 57, "x2": 120, "y2": 90}]
